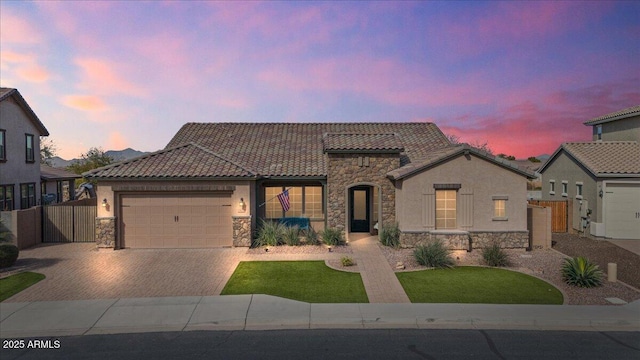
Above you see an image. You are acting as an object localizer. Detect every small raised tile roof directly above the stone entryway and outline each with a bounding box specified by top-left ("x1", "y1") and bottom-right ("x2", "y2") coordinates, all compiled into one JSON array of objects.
[{"x1": 322, "y1": 133, "x2": 404, "y2": 153}]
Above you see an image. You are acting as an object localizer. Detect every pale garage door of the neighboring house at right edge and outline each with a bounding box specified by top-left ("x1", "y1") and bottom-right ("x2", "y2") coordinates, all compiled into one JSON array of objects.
[{"x1": 604, "y1": 184, "x2": 640, "y2": 239}]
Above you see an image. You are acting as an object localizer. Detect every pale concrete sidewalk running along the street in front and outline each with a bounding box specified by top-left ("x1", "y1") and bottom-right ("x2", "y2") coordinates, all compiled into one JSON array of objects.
[{"x1": 0, "y1": 295, "x2": 640, "y2": 339}]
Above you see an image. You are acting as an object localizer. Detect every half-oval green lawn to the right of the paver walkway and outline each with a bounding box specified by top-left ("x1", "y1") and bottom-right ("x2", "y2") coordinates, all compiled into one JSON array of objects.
[{"x1": 396, "y1": 266, "x2": 563, "y2": 304}]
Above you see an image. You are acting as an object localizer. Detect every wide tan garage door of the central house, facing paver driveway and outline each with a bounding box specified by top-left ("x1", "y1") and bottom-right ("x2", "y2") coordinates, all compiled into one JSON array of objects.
[{"x1": 120, "y1": 194, "x2": 233, "y2": 248}]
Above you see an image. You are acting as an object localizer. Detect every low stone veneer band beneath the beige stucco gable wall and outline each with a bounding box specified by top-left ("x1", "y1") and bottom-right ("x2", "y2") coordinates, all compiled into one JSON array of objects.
[{"x1": 400, "y1": 231, "x2": 529, "y2": 250}]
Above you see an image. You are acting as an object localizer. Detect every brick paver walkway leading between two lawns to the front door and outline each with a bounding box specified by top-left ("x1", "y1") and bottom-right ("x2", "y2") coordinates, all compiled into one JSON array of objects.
[{"x1": 349, "y1": 237, "x2": 410, "y2": 303}]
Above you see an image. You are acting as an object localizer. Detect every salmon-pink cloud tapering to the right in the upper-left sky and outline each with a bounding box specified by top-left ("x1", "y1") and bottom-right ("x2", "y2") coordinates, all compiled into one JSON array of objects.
[{"x1": 75, "y1": 58, "x2": 148, "y2": 97}]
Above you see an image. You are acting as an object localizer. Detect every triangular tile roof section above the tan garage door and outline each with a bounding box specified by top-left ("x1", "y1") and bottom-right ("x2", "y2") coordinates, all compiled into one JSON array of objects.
[{"x1": 82, "y1": 143, "x2": 256, "y2": 179}]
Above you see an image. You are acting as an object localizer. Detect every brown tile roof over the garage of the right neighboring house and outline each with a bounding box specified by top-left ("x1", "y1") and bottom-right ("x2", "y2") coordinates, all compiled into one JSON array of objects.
[{"x1": 539, "y1": 141, "x2": 640, "y2": 177}]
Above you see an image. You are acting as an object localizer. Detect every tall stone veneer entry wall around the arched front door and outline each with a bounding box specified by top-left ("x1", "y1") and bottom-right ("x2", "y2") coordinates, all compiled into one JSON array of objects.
[{"x1": 327, "y1": 153, "x2": 400, "y2": 231}]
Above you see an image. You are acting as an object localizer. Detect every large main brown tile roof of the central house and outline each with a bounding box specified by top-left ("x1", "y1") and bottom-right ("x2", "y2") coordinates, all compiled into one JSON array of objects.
[{"x1": 167, "y1": 123, "x2": 450, "y2": 178}]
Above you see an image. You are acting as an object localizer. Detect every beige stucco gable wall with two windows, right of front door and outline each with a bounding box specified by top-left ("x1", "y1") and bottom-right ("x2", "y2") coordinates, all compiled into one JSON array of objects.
[{"x1": 396, "y1": 155, "x2": 527, "y2": 232}]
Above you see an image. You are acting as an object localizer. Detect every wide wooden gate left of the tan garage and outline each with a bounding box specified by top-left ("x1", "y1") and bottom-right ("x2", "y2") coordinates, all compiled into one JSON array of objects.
[{"x1": 42, "y1": 205, "x2": 96, "y2": 243}]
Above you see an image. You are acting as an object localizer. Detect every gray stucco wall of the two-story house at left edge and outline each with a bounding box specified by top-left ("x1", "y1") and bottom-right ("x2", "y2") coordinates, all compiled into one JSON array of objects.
[{"x1": 0, "y1": 98, "x2": 41, "y2": 209}]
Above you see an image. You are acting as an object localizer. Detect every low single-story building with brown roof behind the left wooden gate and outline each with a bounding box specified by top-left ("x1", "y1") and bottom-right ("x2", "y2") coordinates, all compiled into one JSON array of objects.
[{"x1": 40, "y1": 164, "x2": 82, "y2": 204}]
